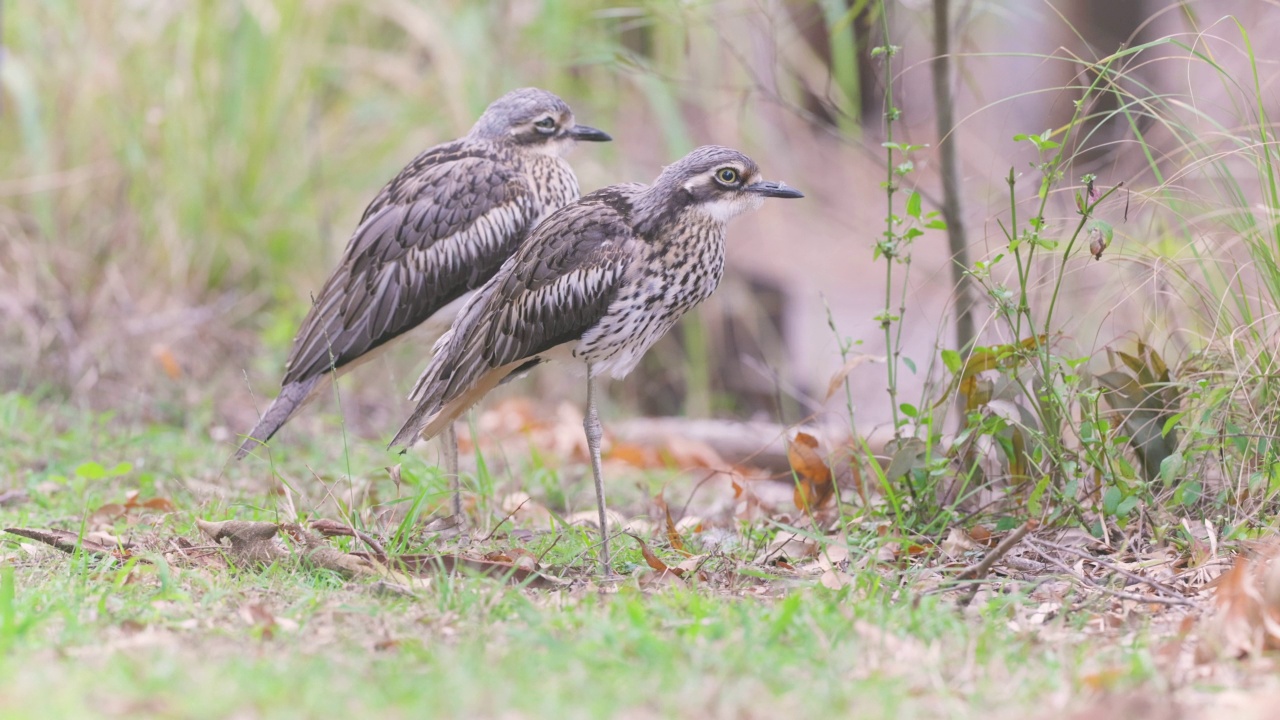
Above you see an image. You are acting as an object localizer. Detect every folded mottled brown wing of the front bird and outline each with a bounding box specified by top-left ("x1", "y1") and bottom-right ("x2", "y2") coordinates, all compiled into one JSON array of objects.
[{"x1": 392, "y1": 186, "x2": 643, "y2": 445}]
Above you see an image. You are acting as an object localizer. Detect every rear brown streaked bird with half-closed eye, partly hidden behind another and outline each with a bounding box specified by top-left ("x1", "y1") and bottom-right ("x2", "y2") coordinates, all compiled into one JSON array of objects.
[{"x1": 236, "y1": 87, "x2": 611, "y2": 458}]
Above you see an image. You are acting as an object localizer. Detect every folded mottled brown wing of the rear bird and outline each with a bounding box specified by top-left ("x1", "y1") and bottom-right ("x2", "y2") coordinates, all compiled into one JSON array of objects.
[{"x1": 283, "y1": 145, "x2": 535, "y2": 386}]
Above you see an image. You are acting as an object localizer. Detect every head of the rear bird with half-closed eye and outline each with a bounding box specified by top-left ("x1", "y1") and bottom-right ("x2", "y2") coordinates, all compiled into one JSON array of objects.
[{"x1": 471, "y1": 87, "x2": 613, "y2": 156}]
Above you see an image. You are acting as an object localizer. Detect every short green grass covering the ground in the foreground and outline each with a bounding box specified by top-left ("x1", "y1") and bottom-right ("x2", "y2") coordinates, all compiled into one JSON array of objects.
[{"x1": 0, "y1": 395, "x2": 1228, "y2": 717}]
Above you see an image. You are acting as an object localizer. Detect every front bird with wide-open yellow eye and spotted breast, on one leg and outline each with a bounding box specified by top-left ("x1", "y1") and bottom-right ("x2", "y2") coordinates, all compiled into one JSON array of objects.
[{"x1": 392, "y1": 145, "x2": 804, "y2": 577}]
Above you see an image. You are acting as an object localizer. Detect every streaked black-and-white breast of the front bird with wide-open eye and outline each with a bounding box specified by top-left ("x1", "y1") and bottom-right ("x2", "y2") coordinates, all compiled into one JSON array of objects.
[{"x1": 573, "y1": 223, "x2": 724, "y2": 378}]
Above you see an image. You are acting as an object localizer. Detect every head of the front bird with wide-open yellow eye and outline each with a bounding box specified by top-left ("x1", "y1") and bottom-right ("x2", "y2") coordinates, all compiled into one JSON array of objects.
[{"x1": 654, "y1": 145, "x2": 804, "y2": 223}]
